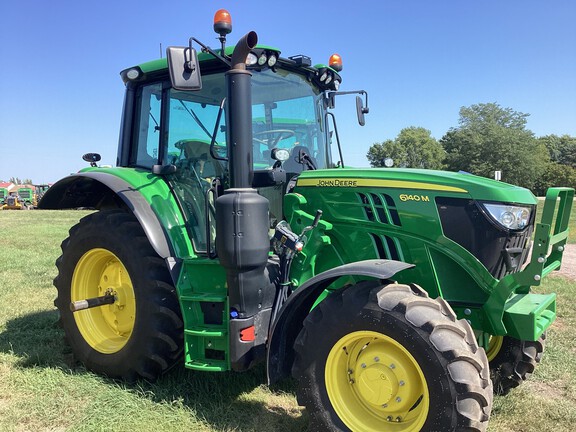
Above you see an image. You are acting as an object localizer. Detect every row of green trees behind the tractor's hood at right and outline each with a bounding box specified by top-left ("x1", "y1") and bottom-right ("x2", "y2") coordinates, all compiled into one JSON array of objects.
[{"x1": 366, "y1": 103, "x2": 576, "y2": 195}]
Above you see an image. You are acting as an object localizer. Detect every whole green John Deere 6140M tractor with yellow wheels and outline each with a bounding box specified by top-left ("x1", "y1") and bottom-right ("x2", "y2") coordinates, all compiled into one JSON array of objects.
[{"x1": 40, "y1": 10, "x2": 574, "y2": 432}]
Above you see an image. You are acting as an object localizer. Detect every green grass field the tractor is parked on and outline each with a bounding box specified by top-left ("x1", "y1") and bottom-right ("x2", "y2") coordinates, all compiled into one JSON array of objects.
[{"x1": 0, "y1": 211, "x2": 576, "y2": 432}]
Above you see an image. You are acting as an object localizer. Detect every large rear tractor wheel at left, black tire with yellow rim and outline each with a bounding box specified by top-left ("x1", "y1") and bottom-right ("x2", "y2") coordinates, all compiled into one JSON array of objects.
[{"x1": 54, "y1": 210, "x2": 183, "y2": 382}]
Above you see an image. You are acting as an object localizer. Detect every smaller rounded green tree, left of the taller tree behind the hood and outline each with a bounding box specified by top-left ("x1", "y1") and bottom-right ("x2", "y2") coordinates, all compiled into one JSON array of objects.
[{"x1": 366, "y1": 126, "x2": 444, "y2": 169}]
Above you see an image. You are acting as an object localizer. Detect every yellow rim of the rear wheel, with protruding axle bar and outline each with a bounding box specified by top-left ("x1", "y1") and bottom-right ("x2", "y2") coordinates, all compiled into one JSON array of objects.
[{"x1": 70, "y1": 249, "x2": 136, "y2": 354}]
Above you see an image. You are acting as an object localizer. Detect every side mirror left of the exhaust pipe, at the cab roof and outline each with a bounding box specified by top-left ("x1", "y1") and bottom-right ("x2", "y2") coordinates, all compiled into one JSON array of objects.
[{"x1": 166, "y1": 42, "x2": 202, "y2": 90}]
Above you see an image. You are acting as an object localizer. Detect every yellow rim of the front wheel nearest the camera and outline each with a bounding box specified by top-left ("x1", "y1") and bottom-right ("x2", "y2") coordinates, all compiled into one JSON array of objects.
[{"x1": 325, "y1": 331, "x2": 430, "y2": 432}]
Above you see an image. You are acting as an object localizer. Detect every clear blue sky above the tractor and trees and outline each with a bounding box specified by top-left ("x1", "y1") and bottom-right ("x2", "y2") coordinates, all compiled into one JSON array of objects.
[{"x1": 0, "y1": 0, "x2": 576, "y2": 183}]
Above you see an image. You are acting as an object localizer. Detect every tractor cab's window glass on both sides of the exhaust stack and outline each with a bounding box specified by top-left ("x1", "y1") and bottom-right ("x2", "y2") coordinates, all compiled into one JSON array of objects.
[{"x1": 131, "y1": 69, "x2": 330, "y2": 177}]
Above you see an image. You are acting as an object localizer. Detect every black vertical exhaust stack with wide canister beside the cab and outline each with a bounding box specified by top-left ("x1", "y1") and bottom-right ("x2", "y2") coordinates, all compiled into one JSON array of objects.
[{"x1": 216, "y1": 32, "x2": 270, "y2": 320}]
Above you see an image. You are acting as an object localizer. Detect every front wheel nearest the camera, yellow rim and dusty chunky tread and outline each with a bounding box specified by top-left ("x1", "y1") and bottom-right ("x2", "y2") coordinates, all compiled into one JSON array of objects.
[{"x1": 292, "y1": 282, "x2": 492, "y2": 432}]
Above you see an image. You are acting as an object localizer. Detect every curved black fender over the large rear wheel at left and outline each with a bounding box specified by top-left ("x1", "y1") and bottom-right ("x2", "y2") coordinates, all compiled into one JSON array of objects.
[{"x1": 38, "y1": 172, "x2": 174, "y2": 259}]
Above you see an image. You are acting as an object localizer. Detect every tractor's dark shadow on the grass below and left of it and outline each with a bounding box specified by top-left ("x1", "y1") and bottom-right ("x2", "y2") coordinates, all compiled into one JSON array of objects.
[{"x1": 0, "y1": 310, "x2": 308, "y2": 432}]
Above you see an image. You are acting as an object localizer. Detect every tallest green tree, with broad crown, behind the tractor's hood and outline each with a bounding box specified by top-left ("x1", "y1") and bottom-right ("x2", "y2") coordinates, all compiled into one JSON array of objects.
[{"x1": 440, "y1": 103, "x2": 550, "y2": 188}]
